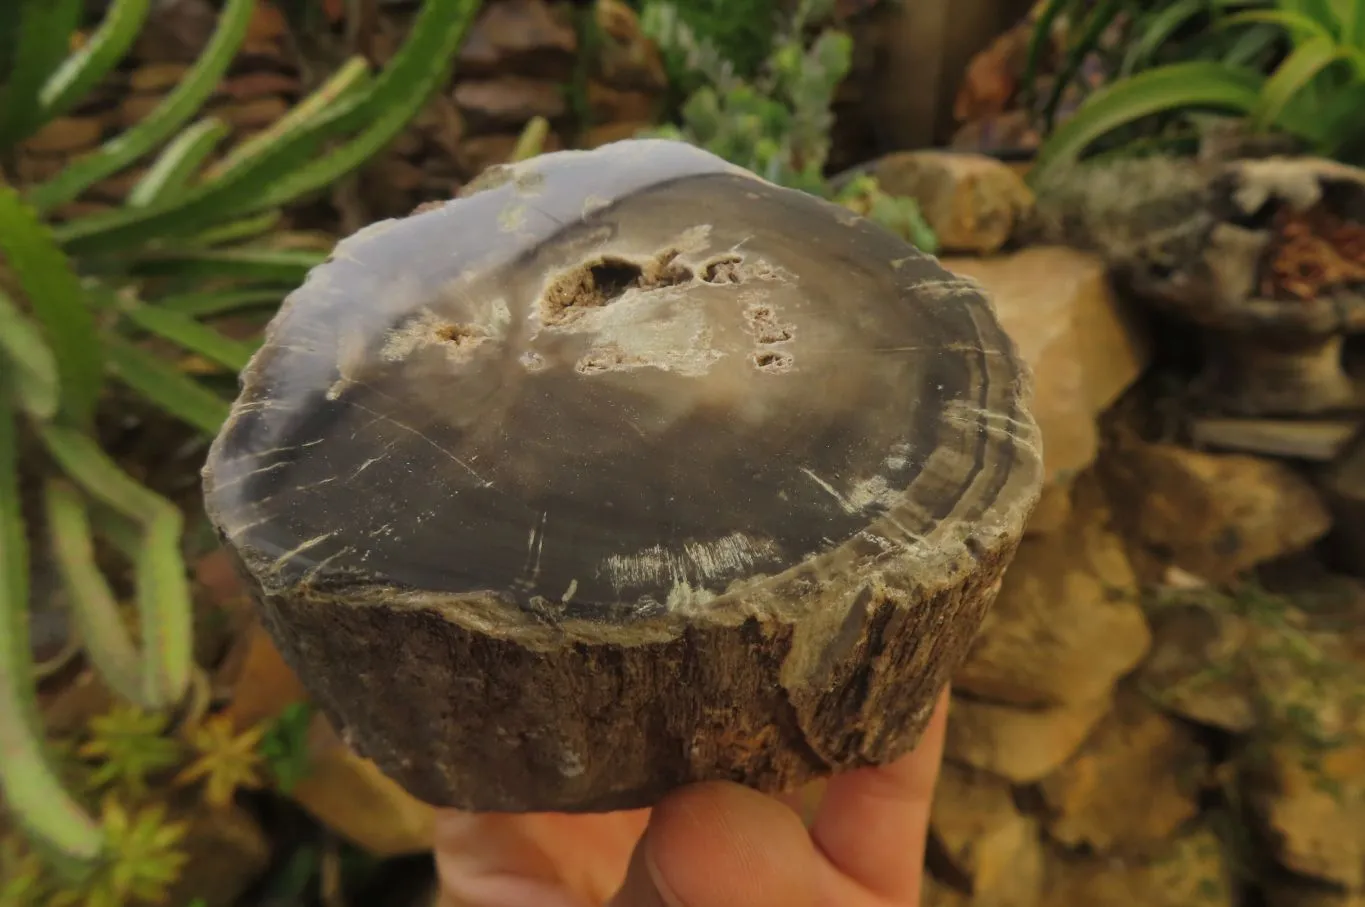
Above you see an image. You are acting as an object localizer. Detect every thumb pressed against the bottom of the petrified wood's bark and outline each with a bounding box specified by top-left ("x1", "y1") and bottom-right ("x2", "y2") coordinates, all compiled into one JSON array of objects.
[{"x1": 610, "y1": 783, "x2": 818, "y2": 907}]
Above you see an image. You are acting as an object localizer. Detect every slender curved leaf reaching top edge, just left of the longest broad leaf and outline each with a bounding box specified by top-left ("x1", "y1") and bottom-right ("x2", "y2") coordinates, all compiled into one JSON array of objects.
[{"x1": 29, "y1": 0, "x2": 254, "y2": 210}]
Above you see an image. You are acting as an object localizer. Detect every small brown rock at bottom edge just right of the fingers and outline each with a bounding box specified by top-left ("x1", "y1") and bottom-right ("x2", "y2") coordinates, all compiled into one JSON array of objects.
[{"x1": 930, "y1": 762, "x2": 1043, "y2": 904}]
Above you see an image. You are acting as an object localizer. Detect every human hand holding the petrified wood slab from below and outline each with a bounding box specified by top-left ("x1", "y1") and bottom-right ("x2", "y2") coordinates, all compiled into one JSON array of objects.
[{"x1": 435, "y1": 690, "x2": 947, "y2": 907}]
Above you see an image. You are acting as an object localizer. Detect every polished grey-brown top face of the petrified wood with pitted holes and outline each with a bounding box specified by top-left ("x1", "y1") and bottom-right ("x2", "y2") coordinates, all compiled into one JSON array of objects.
[{"x1": 205, "y1": 142, "x2": 1036, "y2": 620}]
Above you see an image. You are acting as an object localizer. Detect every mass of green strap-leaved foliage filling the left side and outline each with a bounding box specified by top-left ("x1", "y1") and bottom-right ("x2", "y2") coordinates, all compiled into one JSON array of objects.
[{"x1": 0, "y1": 0, "x2": 479, "y2": 907}]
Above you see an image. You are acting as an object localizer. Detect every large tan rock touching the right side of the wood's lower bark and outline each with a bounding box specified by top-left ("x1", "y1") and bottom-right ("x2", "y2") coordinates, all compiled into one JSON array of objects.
[{"x1": 953, "y1": 475, "x2": 1151, "y2": 706}]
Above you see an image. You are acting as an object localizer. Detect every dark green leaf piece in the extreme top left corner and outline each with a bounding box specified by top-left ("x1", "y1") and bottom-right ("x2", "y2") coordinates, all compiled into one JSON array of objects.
[{"x1": 0, "y1": 0, "x2": 82, "y2": 152}]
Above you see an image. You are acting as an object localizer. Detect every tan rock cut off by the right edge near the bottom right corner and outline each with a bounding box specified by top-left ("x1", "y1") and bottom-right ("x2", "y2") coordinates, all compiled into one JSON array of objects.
[{"x1": 1248, "y1": 743, "x2": 1365, "y2": 891}]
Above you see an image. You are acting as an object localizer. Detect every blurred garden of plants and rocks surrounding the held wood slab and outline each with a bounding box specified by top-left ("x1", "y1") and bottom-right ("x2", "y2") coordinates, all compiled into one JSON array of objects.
[{"x1": 0, "y1": 0, "x2": 1365, "y2": 907}]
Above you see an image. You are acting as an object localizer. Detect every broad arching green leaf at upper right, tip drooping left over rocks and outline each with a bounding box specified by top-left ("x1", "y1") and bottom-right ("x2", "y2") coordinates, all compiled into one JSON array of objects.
[{"x1": 1029, "y1": 60, "x2": 1264, "y2": 184}]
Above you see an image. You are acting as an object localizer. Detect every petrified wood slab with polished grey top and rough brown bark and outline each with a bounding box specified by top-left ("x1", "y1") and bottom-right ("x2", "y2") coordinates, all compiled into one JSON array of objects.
[{"x1": 205, "y1": 141, "x2": 1041, "y2": 810}]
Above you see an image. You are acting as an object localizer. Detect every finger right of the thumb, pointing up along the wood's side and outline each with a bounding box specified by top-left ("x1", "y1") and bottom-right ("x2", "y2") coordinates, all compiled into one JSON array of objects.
[{"x1": 811, "y1": 688, "x2": 949, "y2": 907}]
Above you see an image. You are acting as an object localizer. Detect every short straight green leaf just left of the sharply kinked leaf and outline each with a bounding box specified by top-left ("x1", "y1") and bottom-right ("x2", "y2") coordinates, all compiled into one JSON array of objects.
[{"x1": 45, "y1": 479, "x2": 142, "y2": 708}]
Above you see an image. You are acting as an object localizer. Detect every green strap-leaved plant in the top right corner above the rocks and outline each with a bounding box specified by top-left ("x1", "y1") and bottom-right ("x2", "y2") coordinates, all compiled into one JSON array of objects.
[{"x1": 1024, "y1": 0, "x2": 1365, "y2": 183}]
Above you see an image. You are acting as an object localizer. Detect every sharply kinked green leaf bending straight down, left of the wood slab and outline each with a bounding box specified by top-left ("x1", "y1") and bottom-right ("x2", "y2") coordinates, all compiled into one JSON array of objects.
[{"x1": 40, "y1": 426, "x2": 192, "y2": 708}]
